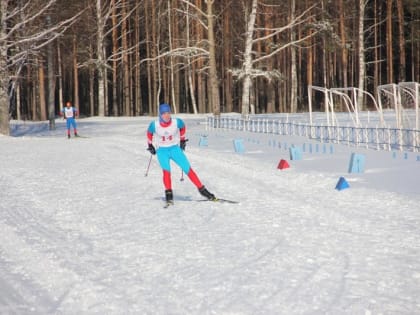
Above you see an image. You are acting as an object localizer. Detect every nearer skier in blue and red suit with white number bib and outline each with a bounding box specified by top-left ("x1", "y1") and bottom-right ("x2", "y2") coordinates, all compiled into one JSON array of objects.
[{"x1": 147, "y1": 104, "x2": 217, "y2": 205}]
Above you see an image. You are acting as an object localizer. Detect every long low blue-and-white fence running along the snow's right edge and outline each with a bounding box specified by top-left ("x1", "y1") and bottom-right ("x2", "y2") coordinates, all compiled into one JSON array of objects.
[{"x1": 207, "y1": 117, "x2": 420, "y2": 152}]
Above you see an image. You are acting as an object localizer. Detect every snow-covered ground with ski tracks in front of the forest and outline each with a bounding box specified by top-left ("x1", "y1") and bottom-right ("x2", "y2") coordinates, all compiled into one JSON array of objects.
[{"x1": 0, "y1": 114, "x2": 420, "y2": 315}]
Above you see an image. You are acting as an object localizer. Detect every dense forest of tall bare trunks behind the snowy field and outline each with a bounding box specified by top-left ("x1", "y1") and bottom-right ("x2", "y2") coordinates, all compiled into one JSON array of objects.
[{"x1": 0, "y1": 0, "x2": 420, "y2": 135}]
